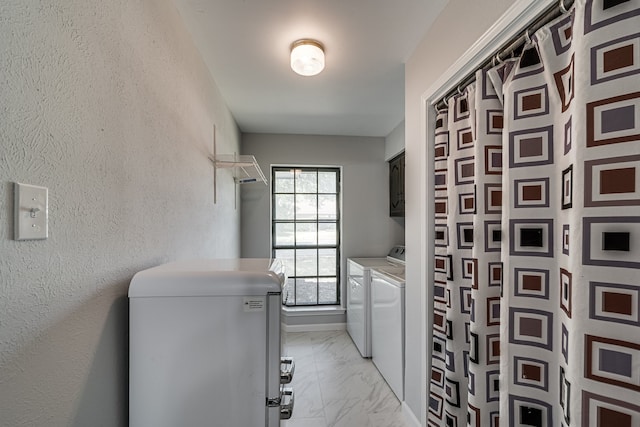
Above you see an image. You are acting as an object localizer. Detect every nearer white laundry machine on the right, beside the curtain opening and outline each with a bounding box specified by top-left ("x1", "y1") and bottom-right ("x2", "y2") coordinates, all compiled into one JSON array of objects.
[{"x1": 371, "y1": 265, "x2": 405, "y2": 401}]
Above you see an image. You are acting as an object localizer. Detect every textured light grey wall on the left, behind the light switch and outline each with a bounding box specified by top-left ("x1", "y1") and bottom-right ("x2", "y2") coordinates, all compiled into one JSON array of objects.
[{"x1": 0, "y1": 0, "x2": 240, "y2": 427}]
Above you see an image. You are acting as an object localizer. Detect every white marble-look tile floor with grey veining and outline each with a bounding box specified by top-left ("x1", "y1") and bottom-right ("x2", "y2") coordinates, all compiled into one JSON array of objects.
[{"x1": 281, "y1": 331, "x2": 410, "y2": 427}]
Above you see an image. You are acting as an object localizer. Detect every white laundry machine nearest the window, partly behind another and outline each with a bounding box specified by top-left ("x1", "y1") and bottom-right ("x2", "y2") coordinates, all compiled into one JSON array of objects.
[{"x1": 347, "y1": 246, "x2": 405, "y2": 357}]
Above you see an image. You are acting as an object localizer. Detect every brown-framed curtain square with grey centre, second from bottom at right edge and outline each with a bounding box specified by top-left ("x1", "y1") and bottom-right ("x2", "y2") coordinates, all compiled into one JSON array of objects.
[{"x1": 585, "y1": 335, "x2": 640, "y2": 391}]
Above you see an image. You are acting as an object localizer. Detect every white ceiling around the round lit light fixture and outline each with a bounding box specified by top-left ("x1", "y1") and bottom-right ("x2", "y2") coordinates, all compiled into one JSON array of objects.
[{"x1": 174, "y1": 0, "x2": 447, "y2": 136}]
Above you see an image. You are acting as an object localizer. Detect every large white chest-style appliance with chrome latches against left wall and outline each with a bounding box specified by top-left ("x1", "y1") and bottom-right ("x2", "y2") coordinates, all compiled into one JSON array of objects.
[{"x1": 129, "y1": 259, "x2": 293, "y2": 427}]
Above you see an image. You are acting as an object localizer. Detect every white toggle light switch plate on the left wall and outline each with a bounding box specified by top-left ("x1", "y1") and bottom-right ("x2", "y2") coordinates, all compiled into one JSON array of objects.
[{"x1": 14, "y1": 182, "x2": 49, "y2": 240}]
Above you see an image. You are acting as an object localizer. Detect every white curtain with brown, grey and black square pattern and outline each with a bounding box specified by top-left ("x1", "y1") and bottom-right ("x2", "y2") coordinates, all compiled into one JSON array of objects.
[{"x1": 428, "y1": 0, "x2": 640, "y2": 427}]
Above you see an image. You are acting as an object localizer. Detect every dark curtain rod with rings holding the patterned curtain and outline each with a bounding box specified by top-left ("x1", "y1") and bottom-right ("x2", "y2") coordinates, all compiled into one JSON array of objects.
[{"x1": 433, "y1": 0, "x2": 574, "y2": 110}]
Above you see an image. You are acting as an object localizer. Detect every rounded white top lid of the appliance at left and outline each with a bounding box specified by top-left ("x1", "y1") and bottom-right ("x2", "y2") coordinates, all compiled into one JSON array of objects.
[{"x1": 129, "y1": 258, "x2": 286, "y2": 298}]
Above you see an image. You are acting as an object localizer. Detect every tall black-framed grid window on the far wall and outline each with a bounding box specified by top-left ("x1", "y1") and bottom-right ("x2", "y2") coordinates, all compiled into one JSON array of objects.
[{"x1": 271, "y1": 167, "x2": 340, "y2": 306}]
